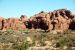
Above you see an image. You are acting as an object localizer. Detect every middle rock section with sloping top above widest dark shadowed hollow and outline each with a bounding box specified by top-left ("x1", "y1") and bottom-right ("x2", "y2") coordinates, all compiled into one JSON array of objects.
[{"x1": 30, "y1": 12, "x2": 48, "y2": 30}]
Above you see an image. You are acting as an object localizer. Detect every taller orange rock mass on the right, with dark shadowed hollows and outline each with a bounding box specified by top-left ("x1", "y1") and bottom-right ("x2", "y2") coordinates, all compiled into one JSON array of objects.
[{"x1": 27, "y1": 9, "x2": 75, "y2": 31}]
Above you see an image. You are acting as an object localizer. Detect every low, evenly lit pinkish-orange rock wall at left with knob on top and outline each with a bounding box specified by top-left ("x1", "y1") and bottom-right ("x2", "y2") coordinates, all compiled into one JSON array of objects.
[{"x1": 0, "y1": 16, "x2": 27, "y2": 30}]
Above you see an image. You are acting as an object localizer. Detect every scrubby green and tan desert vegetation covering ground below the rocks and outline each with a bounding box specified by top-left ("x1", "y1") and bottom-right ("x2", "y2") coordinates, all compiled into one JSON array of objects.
[{"x1": 0, "y1": 28, "x2": 75, "y2": 50}]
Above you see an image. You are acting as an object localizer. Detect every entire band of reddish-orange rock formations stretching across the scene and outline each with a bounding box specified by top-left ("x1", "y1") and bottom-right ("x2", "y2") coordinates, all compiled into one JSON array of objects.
[{"x1": 0, "y1": 9, "x2": 75, "y2": 31}]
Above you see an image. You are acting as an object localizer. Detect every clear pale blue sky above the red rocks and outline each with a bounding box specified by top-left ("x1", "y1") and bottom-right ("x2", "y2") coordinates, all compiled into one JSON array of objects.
[{"x1": 0, "y1": 0, "x2": 75, "y2": 18}]
